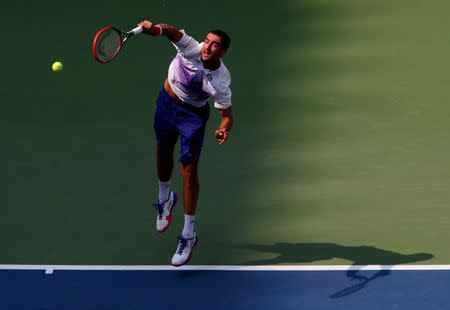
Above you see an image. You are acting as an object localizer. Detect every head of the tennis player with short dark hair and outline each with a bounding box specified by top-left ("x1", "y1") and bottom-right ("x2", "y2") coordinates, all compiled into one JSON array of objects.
[{"x1": 201, "y1": 29, "x2": 231, "y2": 62}]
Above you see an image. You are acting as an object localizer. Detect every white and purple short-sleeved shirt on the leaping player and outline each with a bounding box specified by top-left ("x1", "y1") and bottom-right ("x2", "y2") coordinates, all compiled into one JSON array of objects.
[{"x1": 168, "y1": 30, "x2": 231, "y2": 109}]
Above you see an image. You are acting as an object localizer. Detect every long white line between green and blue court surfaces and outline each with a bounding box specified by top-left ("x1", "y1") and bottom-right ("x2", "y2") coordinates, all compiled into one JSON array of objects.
[{"x1": 0, "y1": 264, "x2": 450, "y2": 274}]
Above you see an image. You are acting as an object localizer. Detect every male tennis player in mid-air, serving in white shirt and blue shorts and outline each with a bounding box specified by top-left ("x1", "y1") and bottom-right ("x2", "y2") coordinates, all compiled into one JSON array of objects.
[{"x1": 138, "y1": 21, "x2": 233, "y2": 266}]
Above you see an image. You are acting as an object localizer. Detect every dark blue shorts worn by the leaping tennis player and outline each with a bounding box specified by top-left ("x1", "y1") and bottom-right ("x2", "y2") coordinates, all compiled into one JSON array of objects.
[{"x1": 153, "y1": 87, "x2": 209, "y2": 164}]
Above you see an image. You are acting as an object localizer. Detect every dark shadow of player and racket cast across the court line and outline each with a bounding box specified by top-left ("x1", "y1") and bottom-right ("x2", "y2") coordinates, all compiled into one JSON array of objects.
[{"x1": 246, "y1": 242, "x2": 433, "y2": 298}]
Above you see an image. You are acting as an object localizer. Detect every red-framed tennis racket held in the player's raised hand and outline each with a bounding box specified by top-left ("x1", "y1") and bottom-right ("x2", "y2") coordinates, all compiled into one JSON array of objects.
[{"x1": 92, "y1": 26, "x2": 143, "y2": 63}]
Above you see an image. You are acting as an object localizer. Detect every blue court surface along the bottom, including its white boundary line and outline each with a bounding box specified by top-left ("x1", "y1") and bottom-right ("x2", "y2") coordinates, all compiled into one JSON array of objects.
[{"x1": 0, "y1": 265, "x2": 450, "y2": 310}]
